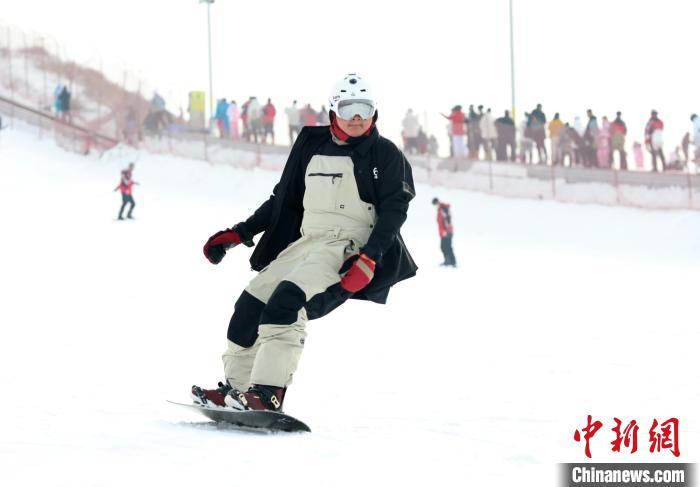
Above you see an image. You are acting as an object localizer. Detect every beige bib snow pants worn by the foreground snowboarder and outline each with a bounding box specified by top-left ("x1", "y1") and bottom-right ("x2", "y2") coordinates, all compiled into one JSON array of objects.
[{"x1": 223, "y1": 155, "x2": 376, "y2": 391}]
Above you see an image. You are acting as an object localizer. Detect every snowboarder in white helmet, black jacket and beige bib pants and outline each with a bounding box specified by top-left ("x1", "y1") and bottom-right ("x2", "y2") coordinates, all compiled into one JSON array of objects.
[{"x1": 192, "y1": 74, "x2": 417, "y2": 411}]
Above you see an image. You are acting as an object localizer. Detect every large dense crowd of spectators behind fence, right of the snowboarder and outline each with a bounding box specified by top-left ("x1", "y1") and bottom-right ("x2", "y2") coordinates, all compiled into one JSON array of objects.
[{"x1": 442, "y1": 104, "x2": 700, "y2": 172}]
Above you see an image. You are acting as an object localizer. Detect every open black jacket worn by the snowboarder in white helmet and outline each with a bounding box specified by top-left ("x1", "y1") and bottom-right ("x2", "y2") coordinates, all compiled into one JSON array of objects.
[{"x1": 239, "y1": 127, "x2": 418, "y2": 318}]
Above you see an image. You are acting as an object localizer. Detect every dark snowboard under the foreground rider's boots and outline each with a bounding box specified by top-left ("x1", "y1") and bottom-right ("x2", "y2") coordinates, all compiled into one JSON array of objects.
[{"x1": 168, "y1": 401, "x2": 311, "y2": 433}]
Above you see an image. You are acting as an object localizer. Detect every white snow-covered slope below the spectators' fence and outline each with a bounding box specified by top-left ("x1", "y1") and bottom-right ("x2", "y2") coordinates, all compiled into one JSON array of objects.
[{"x1": 0, "y1": 130, "x2": 700, "y2": 486}]
